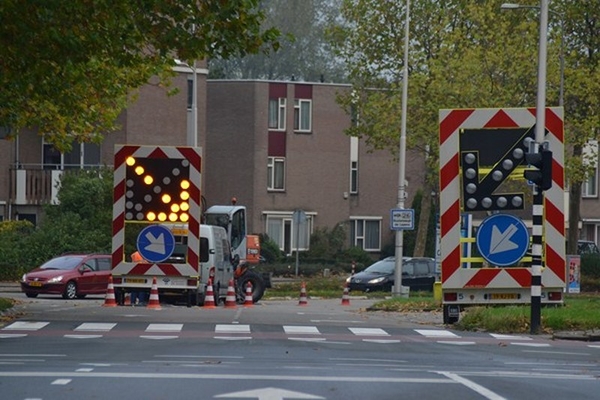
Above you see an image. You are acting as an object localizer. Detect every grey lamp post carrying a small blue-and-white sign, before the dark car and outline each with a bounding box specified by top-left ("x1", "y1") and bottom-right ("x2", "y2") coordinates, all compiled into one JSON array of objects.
[{"x1": 392, "y1": 0, "x2": 410, "y2": 297}]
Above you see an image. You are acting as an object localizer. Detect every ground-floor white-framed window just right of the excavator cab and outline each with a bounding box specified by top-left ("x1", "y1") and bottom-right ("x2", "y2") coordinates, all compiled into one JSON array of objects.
[{"x1": 267, "y1": 212, "x2": 313, "y2": 254}]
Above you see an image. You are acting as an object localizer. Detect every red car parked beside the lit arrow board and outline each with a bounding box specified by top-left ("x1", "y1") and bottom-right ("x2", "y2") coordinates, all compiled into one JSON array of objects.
[{"x1": 21, "y1": 254, "x2": 111, "y2": 299}]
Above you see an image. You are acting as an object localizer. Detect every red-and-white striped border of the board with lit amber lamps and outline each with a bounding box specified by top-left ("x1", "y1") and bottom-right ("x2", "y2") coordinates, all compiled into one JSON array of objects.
[{"x1": 112, "y1": 145, "x2": 202, "y2": 276}]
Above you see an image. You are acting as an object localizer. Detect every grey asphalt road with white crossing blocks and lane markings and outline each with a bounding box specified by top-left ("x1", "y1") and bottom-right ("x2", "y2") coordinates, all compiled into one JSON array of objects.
[{"x1": 0, "y1": 286, "x2": 600, "y2": 400}]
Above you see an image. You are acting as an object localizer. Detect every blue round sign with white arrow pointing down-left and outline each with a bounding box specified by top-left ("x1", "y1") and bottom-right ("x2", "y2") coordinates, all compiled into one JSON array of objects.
[{"x1": 476, "y1": 214, "x2": 529, "y2": 267}]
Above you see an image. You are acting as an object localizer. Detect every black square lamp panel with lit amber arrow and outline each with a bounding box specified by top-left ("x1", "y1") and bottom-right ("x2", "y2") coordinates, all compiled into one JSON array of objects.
[{"x1": 125, "y1": 157, "x2": 190, "y2": 222}]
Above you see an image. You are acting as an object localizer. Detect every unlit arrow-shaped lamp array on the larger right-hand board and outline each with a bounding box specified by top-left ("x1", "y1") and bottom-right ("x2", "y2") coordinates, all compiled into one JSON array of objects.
[{"x1": 461, "y1": 138, "x2": 531, "y2": 211}]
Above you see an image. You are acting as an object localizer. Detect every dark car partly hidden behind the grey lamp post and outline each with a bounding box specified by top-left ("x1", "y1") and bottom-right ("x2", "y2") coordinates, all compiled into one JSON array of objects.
[{"x1": 346, "y1": 257, "x2": 435, "y2": 292}]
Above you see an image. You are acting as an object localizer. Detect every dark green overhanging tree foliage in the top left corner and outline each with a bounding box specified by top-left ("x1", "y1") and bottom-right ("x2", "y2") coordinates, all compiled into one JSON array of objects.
[{"x1": 0, "y1": 0, "x2": 279, "y2": 151}]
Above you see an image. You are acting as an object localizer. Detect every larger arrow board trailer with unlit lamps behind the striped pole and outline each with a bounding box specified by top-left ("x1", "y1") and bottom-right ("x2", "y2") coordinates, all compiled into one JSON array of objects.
[{"x1": 439, "y1": 107, "x2": 566, "y2": 323}]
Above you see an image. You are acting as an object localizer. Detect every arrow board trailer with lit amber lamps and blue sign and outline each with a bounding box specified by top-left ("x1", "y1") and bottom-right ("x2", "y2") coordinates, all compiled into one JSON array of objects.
[{"x1": 112, "y1": 145, "x2": 205, "y2": 306}]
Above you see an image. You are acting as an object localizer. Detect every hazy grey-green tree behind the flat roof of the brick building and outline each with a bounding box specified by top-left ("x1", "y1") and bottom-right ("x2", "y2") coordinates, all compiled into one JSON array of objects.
[{"x1": 209, "y1": 0, "x2": 345, "y2": 82}]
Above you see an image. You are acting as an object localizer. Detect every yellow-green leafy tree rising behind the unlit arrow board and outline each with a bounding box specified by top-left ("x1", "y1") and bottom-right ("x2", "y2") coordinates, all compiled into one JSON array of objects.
[{"x1": 329, "y1": 0, "x2": 600, "y2": 253}]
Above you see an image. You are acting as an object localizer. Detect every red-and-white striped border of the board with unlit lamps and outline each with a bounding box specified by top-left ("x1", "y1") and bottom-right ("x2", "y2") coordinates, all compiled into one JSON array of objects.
[{"x1": 439, "y1": 107, "x2": 566, "y2": 290}]
